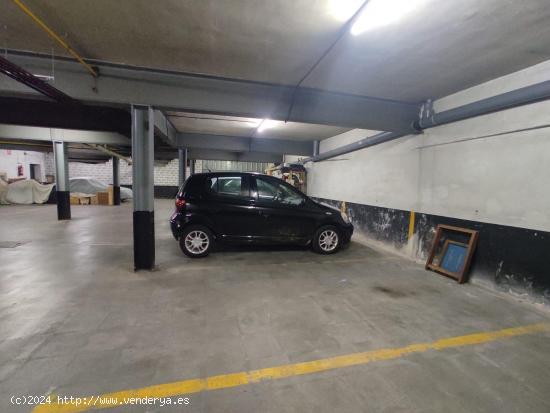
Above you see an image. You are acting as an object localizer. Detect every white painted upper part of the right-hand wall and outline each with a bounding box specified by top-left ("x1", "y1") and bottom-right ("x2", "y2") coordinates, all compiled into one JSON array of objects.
[{"x1": 307, "y1": 62, "x2": 550, "y2": 231}]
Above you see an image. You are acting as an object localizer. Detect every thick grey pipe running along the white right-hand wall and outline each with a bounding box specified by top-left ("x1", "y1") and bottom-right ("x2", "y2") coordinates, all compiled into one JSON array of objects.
[{"x1": 302, "y1": 81, "x2": 550, "y2": 163}]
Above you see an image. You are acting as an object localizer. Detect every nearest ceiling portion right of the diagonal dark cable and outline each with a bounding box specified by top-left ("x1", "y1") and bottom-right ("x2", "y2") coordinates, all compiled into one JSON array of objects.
[{"x1": 304, "y1": 0, "x2": 550, "y2": 101}]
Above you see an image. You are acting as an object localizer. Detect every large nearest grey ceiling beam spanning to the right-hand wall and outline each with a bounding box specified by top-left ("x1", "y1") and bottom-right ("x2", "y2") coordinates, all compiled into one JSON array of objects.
[{"x1": 0, "y1": 52, "x2": 419, "y2": 132}]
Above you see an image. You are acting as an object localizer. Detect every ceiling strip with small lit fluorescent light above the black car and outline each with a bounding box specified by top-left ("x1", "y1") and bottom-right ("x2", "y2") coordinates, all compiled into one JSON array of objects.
[{"x1": 166, "y1": 112, "x2": 349, "y2": 141}]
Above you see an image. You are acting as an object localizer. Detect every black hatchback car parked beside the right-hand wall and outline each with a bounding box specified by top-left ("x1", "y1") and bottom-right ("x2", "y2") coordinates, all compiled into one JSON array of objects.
[{"x1": 170, "y1": 172, "x2": 353, "y2": 257}]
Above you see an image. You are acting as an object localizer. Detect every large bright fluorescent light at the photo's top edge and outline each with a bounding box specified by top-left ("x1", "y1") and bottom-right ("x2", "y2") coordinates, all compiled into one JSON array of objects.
[{"x1": 351, "y1": 0, "x2": 427, "y2": 36}]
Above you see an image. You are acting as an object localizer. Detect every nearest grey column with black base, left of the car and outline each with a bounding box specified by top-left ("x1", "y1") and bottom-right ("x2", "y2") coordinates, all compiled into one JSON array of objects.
[{"x1": 132, "y1": 106, "x2": 155, "y2": 271}]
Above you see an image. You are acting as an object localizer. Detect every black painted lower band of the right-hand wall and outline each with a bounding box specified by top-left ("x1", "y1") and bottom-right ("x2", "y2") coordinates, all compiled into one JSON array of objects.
[{"x1": 317, "y1": 198, "x2": 550, "y2": 304}]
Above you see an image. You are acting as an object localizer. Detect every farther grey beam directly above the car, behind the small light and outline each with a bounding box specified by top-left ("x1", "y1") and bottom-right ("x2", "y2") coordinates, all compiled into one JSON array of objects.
[{"x1": 177, "y1": 133, "x2": 313, "y2": 156}]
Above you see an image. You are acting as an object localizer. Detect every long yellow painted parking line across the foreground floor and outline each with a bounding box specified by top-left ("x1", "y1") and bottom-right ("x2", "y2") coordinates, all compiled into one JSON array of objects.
[{"x1": 33, "y1": 323, "x2": 550, "y2": 413}]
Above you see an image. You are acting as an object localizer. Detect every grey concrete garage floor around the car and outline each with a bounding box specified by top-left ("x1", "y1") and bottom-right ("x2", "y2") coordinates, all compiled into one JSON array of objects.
[{"x1": 0, "y1": 200, "x2": 550, "y2": 413}]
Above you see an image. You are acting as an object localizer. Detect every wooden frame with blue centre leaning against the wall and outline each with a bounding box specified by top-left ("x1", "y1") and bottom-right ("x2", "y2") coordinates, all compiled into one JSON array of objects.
[{"x1": 426, "y1": 225, "x2": 479, "y2": 284}]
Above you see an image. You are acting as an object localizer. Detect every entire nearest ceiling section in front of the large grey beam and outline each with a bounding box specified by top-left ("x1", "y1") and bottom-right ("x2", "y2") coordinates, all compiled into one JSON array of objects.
[{"x1": 0, "y1": 0, "x2": 550, "y2": 102}]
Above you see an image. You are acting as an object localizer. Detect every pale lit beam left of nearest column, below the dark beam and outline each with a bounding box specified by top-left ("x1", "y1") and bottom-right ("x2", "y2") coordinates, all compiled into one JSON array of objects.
[{"x1": 0, "y1": 124, "x2": 131, "y2": 146}]
